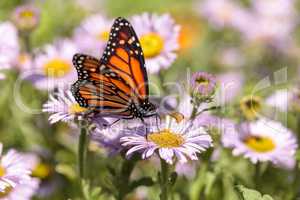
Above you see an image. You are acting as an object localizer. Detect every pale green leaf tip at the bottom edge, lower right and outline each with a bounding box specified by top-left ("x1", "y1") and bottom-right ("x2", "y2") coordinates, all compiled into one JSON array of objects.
[{"x1": 236, "y1": 185, "x2": 273, "y2": 200}]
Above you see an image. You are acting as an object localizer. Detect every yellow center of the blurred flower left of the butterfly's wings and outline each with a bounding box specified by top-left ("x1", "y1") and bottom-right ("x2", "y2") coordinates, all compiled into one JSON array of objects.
[{"x1": 44, "y1": 58, "x2": 72, "y2": 77}]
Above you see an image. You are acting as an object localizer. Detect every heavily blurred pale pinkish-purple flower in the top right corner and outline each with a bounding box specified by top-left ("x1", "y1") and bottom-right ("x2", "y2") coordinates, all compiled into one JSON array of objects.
[{"x1": 238, "y1": 0, "x2": 297, "y2": 50}]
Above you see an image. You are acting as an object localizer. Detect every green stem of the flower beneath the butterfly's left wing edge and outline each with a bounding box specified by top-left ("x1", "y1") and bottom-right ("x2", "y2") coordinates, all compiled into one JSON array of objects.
[{"x1": 78, "y1": 127, "x2": 87, "y2": 179}]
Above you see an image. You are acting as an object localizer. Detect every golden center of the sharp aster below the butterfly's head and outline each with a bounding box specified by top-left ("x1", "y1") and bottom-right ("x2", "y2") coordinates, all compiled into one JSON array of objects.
[{"x1": 148, "y1": 129, "x2": 184, "y2": 148}]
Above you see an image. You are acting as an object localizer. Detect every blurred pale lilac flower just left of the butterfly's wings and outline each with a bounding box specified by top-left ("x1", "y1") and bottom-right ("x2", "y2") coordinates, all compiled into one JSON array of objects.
[{"x1": 23, "y1": 40, "x2": 77, "y2": 90}]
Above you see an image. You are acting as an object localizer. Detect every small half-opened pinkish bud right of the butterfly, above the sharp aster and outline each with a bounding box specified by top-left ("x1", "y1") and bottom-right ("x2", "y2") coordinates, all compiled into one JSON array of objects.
[{"x1": 191, "y1": 72, "x2": 216, "y2": 96}]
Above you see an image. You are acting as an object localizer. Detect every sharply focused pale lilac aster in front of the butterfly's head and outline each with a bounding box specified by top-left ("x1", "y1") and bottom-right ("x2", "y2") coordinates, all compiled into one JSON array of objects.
[{"x1": 120, "y1": 116, "x2": 212, "y2": 164}]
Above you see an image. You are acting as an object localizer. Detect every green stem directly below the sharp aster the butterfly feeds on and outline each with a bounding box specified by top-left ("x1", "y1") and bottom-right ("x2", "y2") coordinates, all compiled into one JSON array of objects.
[{"x1": 159, "y1": 159, "x2": 170, "y2": 200}]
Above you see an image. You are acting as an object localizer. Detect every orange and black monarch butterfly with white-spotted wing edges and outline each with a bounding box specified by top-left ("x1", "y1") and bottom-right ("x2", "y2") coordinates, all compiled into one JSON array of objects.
[{"x1": 71, "y1": 17, "x2": 157, "y2": 122}]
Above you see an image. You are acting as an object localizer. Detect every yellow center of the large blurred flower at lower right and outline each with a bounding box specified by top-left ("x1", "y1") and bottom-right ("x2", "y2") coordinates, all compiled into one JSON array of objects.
[{"x1": 245, "y1": 136, "x2": 275, "y2": 153}]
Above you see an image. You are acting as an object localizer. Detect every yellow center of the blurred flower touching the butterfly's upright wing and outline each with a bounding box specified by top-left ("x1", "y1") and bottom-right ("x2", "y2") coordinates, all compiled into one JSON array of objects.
[{"x1": 140, "y1": 33, "x2": 164, "y2": 58}]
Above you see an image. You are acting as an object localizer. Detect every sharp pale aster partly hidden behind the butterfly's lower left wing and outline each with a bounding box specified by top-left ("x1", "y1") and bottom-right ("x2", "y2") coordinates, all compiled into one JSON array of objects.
[{"x1": 43, "y1": 89, "x2": 87, "y2": 123}]
